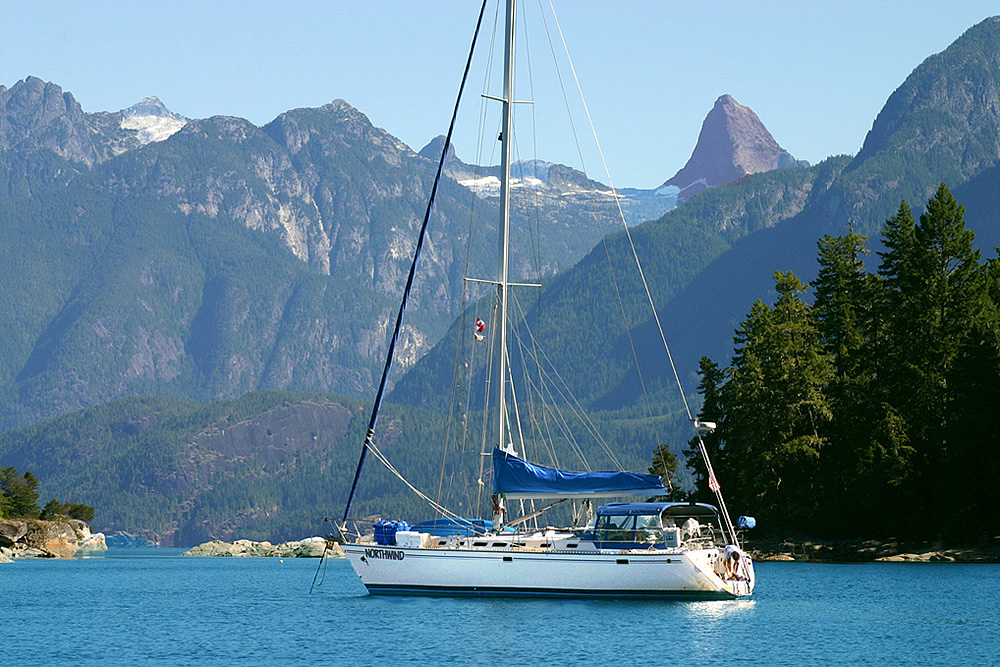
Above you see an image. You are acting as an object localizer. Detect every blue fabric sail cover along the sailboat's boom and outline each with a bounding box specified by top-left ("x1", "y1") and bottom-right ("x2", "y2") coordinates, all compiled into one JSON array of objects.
[{"x1": 493, "y1": 449, "x2": 667, "y2": 498}]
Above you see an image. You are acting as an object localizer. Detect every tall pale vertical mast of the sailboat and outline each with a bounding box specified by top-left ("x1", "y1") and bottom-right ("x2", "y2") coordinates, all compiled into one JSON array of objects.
[{"x1": 493, "y1": 0, "x2": 515, "y2": 530}]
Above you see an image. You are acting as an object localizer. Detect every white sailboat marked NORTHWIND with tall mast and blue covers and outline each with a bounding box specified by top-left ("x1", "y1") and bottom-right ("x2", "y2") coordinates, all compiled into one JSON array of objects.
[{"x1": 335, "y1": 0, "x2": 755, "y2": 599}]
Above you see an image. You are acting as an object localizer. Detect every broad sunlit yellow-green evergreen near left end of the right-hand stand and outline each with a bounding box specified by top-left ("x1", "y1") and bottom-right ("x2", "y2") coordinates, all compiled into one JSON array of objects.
[{"x1": 722, "y1": 271, "x2": 832, "y2": 528}]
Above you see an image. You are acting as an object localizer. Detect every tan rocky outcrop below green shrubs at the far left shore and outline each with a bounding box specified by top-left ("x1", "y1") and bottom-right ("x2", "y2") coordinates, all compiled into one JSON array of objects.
[{"x1": 0, "y1": 519, "x2": 108, "y2": 563}]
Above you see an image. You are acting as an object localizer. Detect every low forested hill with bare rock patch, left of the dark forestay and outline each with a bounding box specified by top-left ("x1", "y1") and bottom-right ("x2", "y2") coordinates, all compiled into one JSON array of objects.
[{"x1": 0, "y1": 392, "x2": 378, "y2": 546}]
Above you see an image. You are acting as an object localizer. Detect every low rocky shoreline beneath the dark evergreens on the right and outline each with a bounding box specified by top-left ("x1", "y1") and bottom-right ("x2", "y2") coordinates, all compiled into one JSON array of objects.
[{"x1": 744, "y1": 537, "x2": 1000, "y2": 563}]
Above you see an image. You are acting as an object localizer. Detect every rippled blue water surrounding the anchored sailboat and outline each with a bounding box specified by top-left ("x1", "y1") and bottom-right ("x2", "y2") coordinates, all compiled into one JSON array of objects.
[{"x1": 0, "y1": 549, "x2": 1000, "y2": 666}]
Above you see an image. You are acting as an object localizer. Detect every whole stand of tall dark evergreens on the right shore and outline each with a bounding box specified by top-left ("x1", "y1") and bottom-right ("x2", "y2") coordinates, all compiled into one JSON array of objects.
[{"x1": 685, "y1": 184, "x2": 1000, "y2": 541}]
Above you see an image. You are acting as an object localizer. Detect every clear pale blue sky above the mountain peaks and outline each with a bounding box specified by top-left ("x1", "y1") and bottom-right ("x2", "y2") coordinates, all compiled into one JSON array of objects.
[{"x1": 0, "y1": 0, "x2": 1000, "y2": 188}]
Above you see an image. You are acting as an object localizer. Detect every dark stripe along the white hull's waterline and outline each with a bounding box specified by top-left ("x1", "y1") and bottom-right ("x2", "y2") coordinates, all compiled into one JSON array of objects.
[{"x1": 365, "y1": 584, "x2": 737, "y2": 600}]
